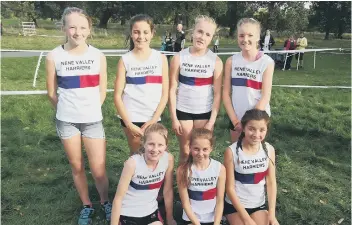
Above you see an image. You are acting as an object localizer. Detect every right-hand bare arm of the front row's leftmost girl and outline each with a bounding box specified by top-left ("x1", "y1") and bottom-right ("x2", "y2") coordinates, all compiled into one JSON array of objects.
[{"x1": 163, "y1": 154, "x2": 174, "y2": 224}]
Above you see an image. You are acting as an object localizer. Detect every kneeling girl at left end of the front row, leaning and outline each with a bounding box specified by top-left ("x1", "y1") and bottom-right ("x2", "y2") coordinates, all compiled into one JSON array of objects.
[{"x1": 111, "y1": 123, "x2": 176, "y2": 225}]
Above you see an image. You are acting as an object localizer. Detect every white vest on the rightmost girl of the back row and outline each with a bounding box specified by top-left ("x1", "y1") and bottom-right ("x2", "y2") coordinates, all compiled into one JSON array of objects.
[{"x1": 231, "y1": 52, "x2": 274, "y2": 120}]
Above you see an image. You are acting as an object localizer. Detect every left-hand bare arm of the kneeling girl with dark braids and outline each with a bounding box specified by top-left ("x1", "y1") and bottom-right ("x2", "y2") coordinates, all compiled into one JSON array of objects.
[{"x1": 224, "y1": 148, "x2": 251, "y2": 221}]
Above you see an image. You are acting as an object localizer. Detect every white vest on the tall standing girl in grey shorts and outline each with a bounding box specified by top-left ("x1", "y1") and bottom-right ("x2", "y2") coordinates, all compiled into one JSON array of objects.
[{"x1": 52, "y1": 45, "x2": 103, "y2": 123}]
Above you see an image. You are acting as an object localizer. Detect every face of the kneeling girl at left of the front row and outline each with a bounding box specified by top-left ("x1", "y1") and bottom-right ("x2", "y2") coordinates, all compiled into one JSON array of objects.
[{"x1": 144, "y1": 132, "x2": 167, "y2": 161}]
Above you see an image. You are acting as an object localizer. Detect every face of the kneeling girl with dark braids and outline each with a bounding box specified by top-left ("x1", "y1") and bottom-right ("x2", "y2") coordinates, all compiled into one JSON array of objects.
[{"x1": 243, "y1": 120, "x2": 268, "y2": 145}]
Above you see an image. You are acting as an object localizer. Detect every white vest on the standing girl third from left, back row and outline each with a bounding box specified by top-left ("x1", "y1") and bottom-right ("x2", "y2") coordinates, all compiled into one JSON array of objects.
[{"x1": 176, "y1": 48, "x2": 217, "y2": 114}]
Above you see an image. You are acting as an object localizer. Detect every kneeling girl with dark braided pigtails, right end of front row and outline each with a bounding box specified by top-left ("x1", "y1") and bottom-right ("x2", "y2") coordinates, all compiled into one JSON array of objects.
[{"x1": 224, "y1": 109, "x2": 279, "y2": 225}]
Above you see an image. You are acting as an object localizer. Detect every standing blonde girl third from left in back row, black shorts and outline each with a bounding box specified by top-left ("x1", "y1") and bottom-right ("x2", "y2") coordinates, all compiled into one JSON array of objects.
[{"x1": 169, "y1": 16, "x2": 223, "y2": 162}]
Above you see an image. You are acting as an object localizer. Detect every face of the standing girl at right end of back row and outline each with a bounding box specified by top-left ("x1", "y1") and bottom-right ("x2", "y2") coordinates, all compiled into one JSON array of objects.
[{"x1": 237, "y1": 23, "x2": 260, "y2": 51}]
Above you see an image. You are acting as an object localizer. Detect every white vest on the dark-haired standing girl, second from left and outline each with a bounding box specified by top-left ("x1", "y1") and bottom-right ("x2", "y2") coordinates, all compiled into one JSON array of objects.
[{"x1": 122, "y1": 49, "x2": 163, "y2": 122}]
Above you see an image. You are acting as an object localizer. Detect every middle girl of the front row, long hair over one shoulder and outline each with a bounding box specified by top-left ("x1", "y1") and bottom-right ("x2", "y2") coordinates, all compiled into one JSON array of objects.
[{"x1": 177, "y1": 128, "x2": 226, "y2": 225}]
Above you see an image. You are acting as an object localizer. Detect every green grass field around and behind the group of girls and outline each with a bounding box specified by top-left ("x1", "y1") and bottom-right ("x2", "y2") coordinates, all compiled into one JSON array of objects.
[{"x1": 1, "y1": 31, "x2": 351, "y2": 225}]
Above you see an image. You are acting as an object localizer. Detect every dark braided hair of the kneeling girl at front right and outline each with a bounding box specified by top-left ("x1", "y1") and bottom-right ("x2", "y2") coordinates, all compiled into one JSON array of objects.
[{"x1": 236, "y1": 109, "x2": 275, "y2": 165}]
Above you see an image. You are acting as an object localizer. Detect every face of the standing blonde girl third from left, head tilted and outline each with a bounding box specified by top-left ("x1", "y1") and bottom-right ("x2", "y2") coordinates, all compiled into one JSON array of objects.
[{"x1": 192, "y1": 20, "x2": 215, "y2": 50}]
